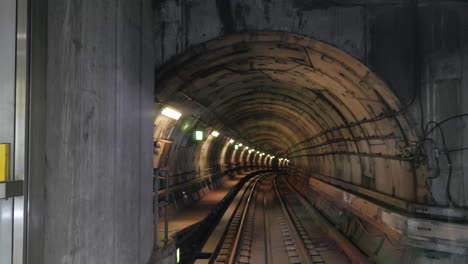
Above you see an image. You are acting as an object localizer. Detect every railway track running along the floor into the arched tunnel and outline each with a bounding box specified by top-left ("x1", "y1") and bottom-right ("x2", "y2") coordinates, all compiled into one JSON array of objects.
[{"x1": 195, "y1": 173, "x2": 366, "y2": 264}]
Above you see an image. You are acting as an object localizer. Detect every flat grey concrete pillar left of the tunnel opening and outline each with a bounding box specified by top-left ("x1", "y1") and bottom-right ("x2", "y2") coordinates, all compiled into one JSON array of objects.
[{"x1": 28, "y1": 0, "x2": 154, "y2": 264}]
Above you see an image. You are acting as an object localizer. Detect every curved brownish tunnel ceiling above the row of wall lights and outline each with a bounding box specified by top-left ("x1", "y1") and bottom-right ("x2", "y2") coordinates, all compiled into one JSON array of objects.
[{"x1": 156, "y1": 32, "x2": 424, "y2": 202}]
